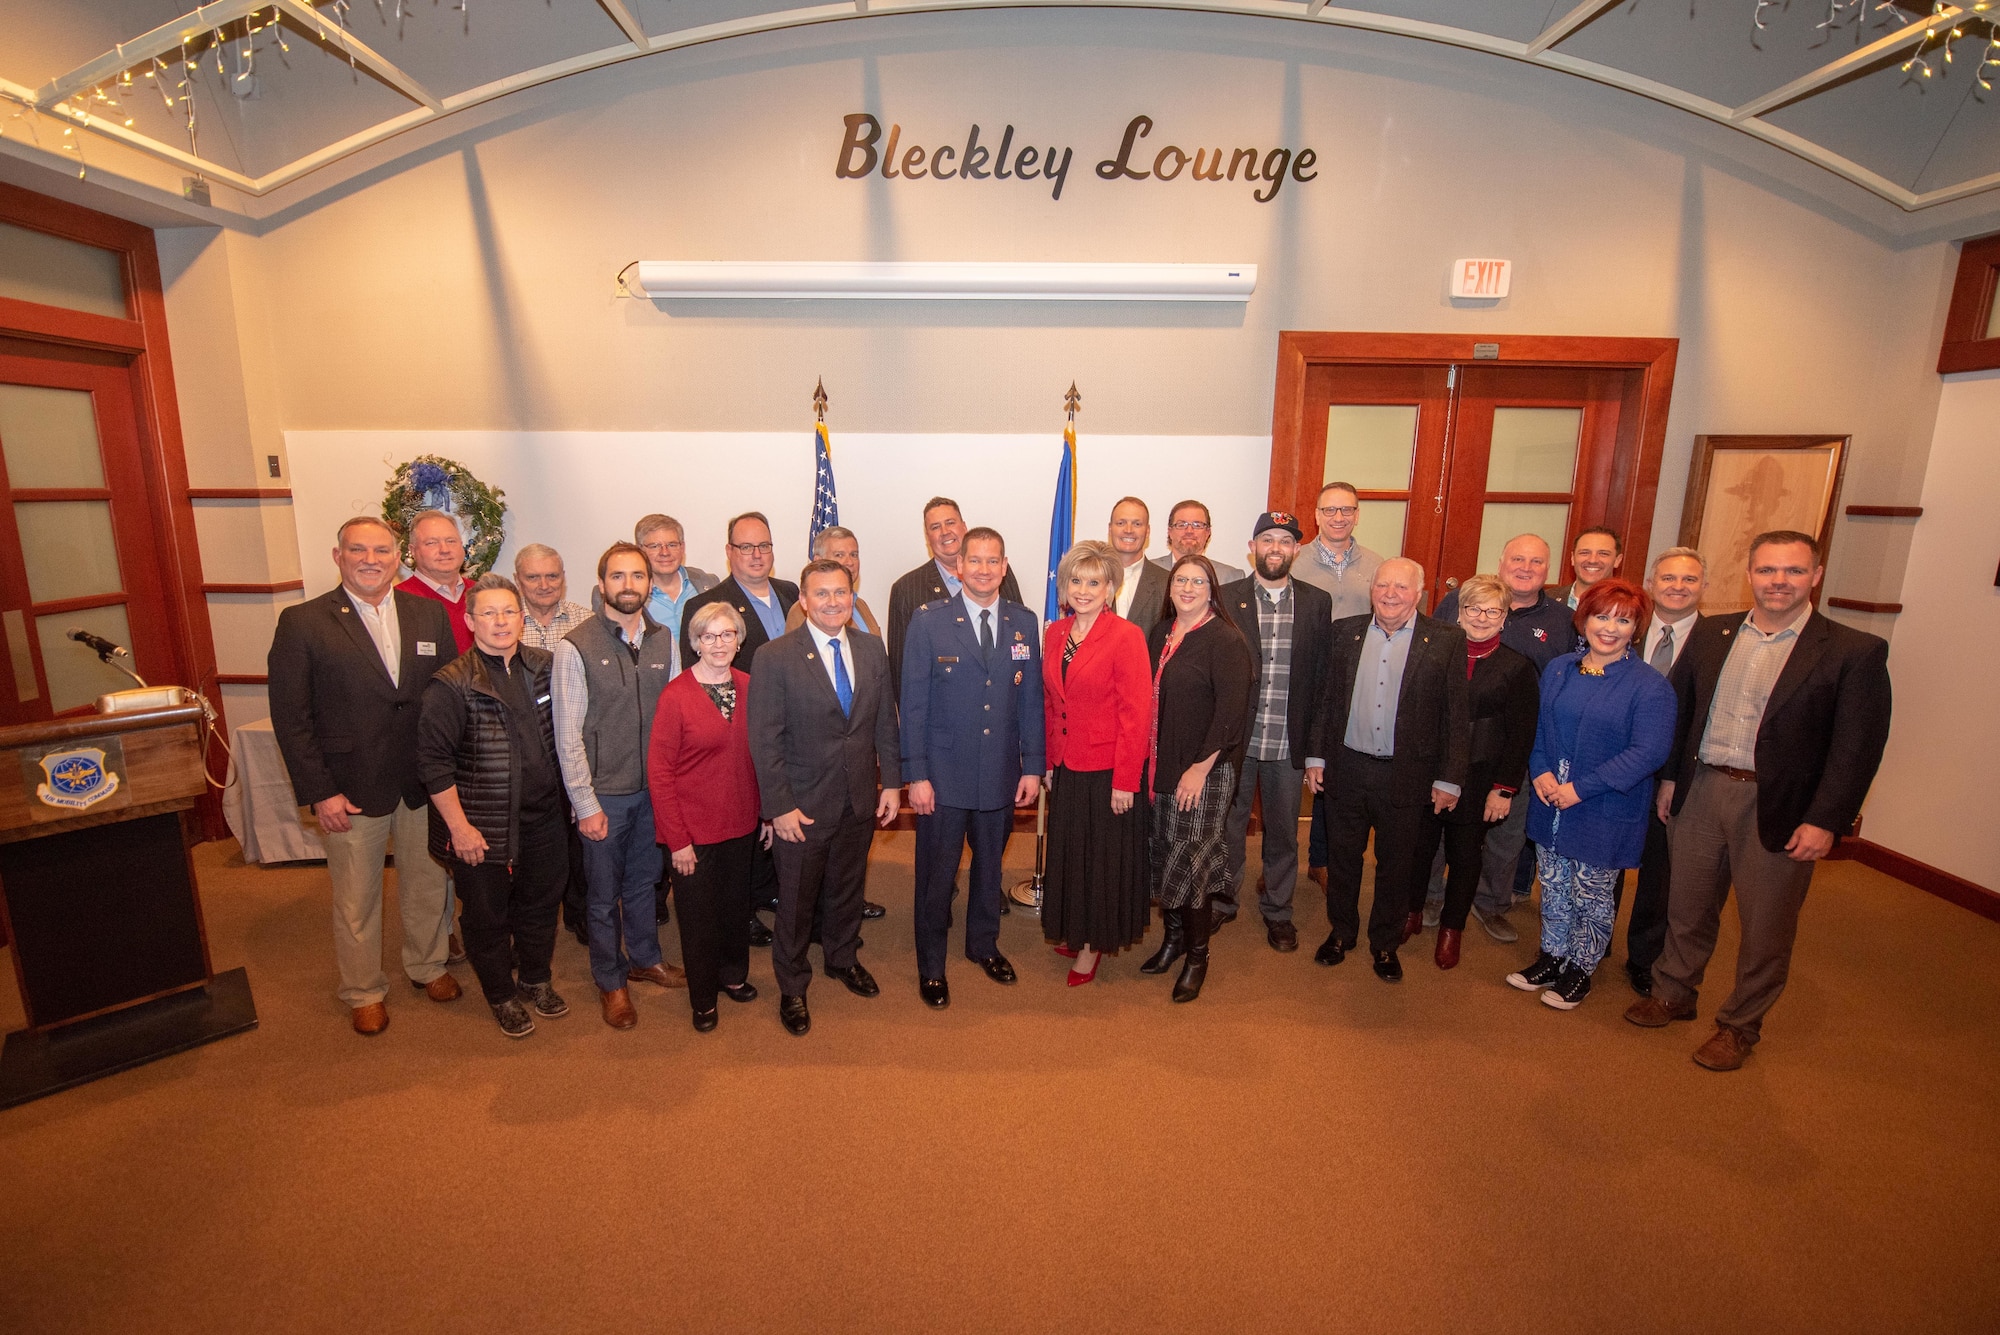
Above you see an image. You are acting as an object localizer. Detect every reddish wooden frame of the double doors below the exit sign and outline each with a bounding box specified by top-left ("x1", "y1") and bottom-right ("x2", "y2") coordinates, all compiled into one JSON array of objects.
[{"x1": 1268, "y1": 330, "x2": 1680, "y2": 572}]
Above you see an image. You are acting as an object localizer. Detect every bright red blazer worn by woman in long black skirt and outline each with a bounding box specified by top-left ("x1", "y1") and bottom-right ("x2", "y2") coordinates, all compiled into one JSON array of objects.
[{"x1": 1042, "y1": 608, "x2": 1152, "y2": 793}]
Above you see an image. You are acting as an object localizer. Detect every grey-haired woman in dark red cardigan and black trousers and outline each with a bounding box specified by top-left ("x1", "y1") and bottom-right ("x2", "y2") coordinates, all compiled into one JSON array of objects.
[{"x1": 646, "y1": 604, "x2": 770, "y2": 1033}]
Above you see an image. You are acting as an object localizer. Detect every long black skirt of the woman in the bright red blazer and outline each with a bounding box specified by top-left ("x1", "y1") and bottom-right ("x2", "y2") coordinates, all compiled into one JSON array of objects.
[{"x1": 1042, "y1": 767, "x2": 1150, "y2": 951}]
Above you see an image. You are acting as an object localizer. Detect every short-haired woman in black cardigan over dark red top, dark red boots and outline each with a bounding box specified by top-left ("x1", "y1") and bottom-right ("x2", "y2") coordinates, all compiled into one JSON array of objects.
[{"x1": 1402, "y1": 576, "x2": 1542, "y2": 969}]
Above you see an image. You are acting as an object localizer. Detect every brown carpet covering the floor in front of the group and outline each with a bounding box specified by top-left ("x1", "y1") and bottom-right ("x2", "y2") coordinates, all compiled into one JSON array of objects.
[{"x1": 0, "y1": 833, "x2": 2000, "y2": 1335}]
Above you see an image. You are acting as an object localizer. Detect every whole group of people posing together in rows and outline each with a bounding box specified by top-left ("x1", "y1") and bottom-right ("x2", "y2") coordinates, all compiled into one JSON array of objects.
[{"x1": 270, "y1": 482, "x2": 1890, "y2": 1069}]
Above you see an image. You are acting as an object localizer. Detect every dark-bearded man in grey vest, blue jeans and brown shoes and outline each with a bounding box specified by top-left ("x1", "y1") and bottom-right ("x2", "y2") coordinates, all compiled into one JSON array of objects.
[{"x1": 550, "y1": 542, "x2": 688, "y2": 1029}]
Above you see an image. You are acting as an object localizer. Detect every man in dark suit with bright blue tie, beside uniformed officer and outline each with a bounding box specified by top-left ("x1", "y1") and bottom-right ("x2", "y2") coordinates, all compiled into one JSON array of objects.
[{"x1": 750, "y1": 560, "x2": 902, "y2": 1033}]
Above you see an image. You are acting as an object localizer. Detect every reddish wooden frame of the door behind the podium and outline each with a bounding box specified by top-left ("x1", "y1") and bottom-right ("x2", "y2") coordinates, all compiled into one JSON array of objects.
[{"x1": 0, "y1": 182, "x2": 228, "y2": 839}]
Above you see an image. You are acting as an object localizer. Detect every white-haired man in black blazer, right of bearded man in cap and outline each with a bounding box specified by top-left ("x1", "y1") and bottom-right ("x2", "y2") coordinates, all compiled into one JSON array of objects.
[{"x1": 1312, "y1": 556, "x2": 1470, "y2": 983}]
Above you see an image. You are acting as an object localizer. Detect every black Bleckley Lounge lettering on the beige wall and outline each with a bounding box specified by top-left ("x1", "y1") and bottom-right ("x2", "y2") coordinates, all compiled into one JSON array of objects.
[{"x1": 834, "y1": 112, "x2": 1318, "y2": 204}]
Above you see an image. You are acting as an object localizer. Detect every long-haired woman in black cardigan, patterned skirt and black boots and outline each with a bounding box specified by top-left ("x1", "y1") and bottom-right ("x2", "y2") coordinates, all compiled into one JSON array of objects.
[{"x1": 1140, "y1": 556, "x2": 1256, "y2": 1001}]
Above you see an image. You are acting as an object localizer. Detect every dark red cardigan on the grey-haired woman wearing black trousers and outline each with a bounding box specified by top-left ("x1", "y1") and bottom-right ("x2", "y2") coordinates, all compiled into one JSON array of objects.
[{"x1": 646, "y1": 668, "x2": 758, "y2": 851}]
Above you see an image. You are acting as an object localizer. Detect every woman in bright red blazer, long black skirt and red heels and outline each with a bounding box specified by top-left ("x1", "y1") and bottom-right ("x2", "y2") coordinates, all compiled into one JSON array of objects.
[{"x1": 1042, "y1": 542, "x2": 1152, "y2": 987}]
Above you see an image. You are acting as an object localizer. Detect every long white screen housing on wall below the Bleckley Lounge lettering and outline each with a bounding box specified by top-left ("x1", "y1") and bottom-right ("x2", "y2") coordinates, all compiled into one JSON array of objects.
[{"x1": 638, "y1": 260, "x2": 1256, "y2": 302}]
